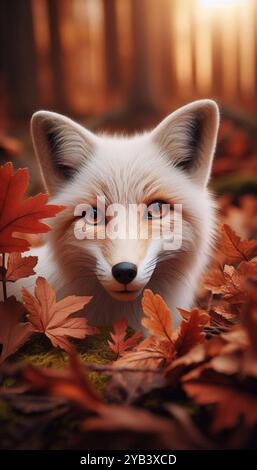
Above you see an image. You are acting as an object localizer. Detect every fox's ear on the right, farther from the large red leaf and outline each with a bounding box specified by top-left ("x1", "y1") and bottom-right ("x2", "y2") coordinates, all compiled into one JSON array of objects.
[{"x1": 152, "y1": 100, "x2": 219, "y2": 186}]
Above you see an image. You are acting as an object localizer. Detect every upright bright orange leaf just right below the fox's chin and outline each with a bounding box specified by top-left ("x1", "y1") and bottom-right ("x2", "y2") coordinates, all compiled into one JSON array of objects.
[{"x1": 142, "y1": 289, "x2": 173, "y2": 341}]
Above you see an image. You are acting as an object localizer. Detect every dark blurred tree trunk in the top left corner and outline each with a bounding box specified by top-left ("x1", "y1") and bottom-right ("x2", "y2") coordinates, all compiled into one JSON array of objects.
[{"x1": 0, "y1": 0, "x2": 38, "y2": 117}]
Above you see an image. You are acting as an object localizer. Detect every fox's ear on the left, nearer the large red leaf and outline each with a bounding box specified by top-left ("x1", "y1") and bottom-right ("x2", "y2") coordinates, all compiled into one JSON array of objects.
[{"x1": 31, "y1": 111, "x2": 97, "y2": 194}]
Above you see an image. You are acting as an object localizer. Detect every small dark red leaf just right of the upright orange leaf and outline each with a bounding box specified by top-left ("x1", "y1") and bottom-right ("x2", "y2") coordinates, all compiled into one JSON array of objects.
[{"x1": 174, "y1": 308, "x2": 210, "y2": 356}]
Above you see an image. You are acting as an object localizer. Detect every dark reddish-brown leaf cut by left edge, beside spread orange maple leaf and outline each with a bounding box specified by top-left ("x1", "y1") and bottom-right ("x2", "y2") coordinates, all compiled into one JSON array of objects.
[{"x1": 0, "y1": 296, "x2": 33, "y2": 363}]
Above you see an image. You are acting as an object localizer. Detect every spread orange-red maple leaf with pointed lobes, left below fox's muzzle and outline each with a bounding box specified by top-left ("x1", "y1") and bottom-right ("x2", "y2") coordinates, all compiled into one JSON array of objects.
[{"x1": 22, "y1": 277, "x2": 97, "y2": 351}]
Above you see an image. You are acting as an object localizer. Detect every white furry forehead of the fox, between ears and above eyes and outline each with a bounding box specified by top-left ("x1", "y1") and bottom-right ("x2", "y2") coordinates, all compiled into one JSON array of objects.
[{"x1": 61, "y1": 136, "x2": 190, "y2": 204}]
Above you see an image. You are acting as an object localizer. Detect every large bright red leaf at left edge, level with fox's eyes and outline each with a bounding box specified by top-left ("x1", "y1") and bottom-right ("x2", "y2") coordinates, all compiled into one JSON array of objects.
[{"x1": 0, "y1": 163, "x2": 64, "y2": 253}]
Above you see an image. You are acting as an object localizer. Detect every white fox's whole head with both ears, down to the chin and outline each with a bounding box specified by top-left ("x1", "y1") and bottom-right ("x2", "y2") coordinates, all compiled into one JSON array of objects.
[{"x1": 31, "y1": 100, "x2": 219, "y2": 324}]
